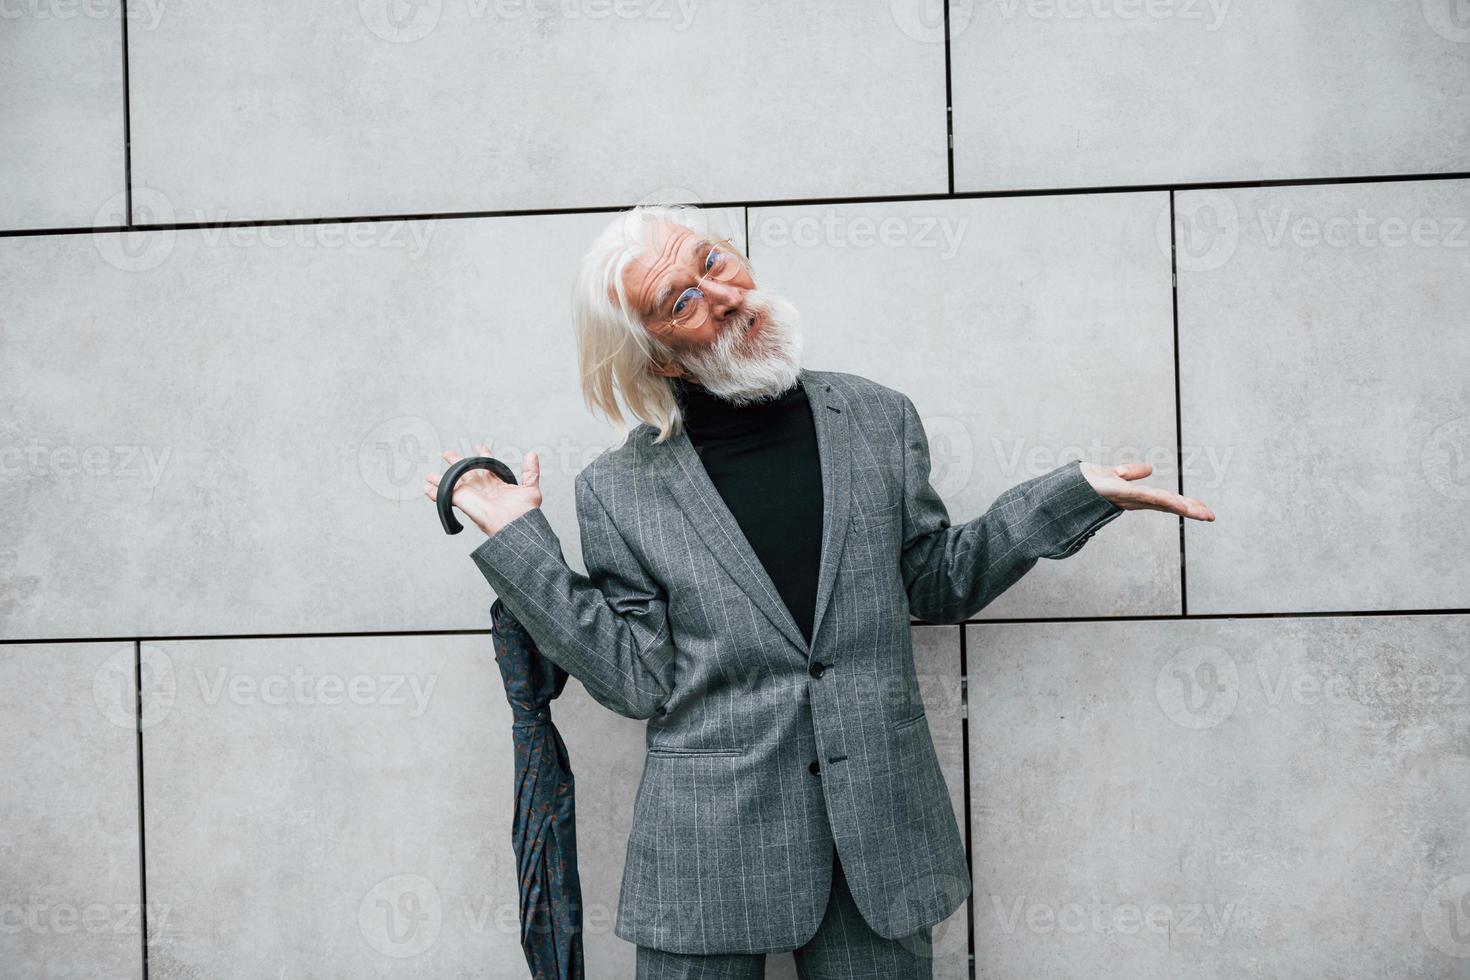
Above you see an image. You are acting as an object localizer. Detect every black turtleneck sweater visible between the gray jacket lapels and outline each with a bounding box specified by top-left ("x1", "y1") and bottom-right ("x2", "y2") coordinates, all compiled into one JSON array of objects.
[{"x1": 673, "y1": 378, "x2": 822, "y2": 645}]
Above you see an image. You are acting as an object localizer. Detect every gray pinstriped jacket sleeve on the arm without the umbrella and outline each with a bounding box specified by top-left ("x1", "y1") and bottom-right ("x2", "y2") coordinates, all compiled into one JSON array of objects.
[{"x1": 903, "y1": 395, "x2": 1123, "y2": 623}]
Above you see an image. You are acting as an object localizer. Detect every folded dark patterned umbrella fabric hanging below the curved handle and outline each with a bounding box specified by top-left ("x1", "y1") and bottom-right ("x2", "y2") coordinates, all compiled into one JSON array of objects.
[{"x1": 490, "y1": 598, "x2": 584, "y2": 980}]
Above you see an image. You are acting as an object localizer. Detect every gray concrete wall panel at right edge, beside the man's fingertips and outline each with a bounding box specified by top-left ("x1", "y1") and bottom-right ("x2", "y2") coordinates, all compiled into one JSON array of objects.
[{"x1": 1176, "y1": 181, "x2": 1470, "y2": 613}]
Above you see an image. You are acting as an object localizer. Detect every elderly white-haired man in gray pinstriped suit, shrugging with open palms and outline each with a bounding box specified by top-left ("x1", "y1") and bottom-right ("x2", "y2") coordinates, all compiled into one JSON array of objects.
[{"x1": 425, "y1": 207, "x2": 1214, "y2": 979}]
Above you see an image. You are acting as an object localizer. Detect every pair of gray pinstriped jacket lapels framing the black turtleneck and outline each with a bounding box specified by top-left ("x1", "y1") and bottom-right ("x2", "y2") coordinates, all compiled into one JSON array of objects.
[{"x1": 651, "y1": 369, "x2": 851, "y2": 660}]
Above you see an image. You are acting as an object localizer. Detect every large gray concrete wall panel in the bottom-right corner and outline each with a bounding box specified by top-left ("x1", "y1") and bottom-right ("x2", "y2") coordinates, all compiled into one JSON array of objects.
[{"x1": 967, "y1": 616, "x2": 1470, "y2": 980}]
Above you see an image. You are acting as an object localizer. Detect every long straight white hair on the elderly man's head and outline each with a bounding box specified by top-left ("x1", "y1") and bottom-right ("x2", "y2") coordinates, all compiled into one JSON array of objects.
[{"x1": 572, "y1": 204, "x2": 709, "y2": 442}]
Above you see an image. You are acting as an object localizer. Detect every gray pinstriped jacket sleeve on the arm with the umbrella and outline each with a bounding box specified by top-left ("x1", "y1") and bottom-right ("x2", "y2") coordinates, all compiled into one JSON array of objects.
[{"x1": 470, "y1": 470, "x2": 675, "y2": 718}]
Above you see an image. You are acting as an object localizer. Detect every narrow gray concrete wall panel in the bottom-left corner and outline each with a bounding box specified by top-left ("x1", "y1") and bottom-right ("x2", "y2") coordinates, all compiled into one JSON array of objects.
[{"x1": 0, "y1": 642, "x2": 143, "y2": 977}]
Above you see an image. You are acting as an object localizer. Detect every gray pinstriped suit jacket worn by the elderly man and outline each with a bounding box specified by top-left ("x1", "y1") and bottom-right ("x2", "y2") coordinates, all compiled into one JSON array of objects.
[{"x1": 472, "y1": 370, "x2": 1123, "y2": 954}]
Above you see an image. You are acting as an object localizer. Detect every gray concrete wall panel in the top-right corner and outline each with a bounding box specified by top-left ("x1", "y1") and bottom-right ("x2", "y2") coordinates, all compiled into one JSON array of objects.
[{"x1": 951, "y1": 0, "x2": 1470, "y2": 191}]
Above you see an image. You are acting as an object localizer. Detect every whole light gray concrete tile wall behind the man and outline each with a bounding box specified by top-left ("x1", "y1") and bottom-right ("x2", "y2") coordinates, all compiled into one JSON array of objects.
[{"x1": 0, "y1": 0, "x2": 1470, "y2": 980}]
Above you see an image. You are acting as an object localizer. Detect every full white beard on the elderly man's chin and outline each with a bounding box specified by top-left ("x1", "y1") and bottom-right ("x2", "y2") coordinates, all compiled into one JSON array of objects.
[{"x1": 675, "y1": 289, "x2": 803, "y2": 406}]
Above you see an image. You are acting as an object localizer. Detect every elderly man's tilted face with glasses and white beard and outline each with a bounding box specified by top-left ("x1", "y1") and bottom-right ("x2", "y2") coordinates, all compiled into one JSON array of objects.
[{"x1": 623, "y1": 222, "x2": 801, "y2": 403}]
